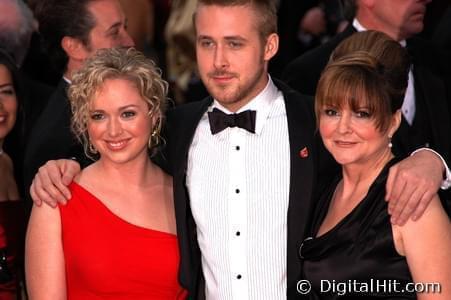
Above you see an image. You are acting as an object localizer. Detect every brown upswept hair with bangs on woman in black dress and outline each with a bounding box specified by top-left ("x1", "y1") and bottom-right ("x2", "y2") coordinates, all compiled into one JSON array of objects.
[{"x1": 315, "y1": 31, "x2": 410, "y2": 132}]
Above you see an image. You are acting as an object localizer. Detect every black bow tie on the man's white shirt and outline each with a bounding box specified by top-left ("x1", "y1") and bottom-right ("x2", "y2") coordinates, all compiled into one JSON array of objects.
[{"x1": 208, "y1": 108, "x2": 256, "y2": 134}]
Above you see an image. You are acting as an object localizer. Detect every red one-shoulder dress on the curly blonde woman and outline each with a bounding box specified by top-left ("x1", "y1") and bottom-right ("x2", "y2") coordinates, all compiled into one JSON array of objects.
[{"x1": 60, "y1": 183, "x2": 186, "y2": 300}]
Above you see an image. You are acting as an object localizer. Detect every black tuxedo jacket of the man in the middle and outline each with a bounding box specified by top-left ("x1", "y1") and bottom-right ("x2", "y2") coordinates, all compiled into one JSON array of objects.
[{"x1": 166, "y1": 80, "x2": 334, "y2": 298}]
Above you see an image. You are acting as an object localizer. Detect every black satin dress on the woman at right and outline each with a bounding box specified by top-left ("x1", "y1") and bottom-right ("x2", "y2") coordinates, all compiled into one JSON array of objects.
[{"x1": 300, "y1": 159, "x2": 416, "y2": 299}]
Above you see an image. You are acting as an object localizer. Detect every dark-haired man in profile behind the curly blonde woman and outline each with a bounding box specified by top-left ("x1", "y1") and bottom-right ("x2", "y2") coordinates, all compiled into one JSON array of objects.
[{"x1": 24, "y1": 0, "x2": 134, "y2": 210}]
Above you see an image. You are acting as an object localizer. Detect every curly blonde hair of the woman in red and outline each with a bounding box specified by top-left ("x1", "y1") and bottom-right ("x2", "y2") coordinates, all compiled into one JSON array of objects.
[{"x1": 68, "y1": 48, "x2": 168, "y2": 159}]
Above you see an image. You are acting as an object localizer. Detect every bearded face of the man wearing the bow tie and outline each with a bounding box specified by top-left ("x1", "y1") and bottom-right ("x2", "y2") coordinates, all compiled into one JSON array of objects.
[{"x1": 195, "y1": 5, "x2": 278, "y2": 111}]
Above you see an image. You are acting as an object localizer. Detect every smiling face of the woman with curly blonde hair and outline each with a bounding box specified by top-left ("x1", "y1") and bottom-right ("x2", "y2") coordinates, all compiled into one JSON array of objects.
[{"x1": 88, "y1": 79, "x2": 153, "y2": 163}]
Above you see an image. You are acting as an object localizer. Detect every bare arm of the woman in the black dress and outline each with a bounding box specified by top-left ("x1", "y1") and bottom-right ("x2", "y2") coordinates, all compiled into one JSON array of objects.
[{"x1": 393, "y1": 196, "x2": 451, "y2": 300}]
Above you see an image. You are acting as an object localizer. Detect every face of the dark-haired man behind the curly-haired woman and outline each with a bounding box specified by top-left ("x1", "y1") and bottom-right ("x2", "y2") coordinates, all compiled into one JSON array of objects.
[{"x1": 87, "y1": 0, "x2": 135, "y2": 54}]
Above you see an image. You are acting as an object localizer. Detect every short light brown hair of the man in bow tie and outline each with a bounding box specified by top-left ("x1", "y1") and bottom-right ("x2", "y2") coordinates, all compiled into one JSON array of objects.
[{"x1": 193, "y1": 0, "x2": 277, "y2": 41}]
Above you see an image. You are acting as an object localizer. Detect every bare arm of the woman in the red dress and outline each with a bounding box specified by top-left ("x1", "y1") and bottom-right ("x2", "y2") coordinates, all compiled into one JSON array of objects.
[{"x1": 25, "y1": 205, "x2": 66, "y2": 300}]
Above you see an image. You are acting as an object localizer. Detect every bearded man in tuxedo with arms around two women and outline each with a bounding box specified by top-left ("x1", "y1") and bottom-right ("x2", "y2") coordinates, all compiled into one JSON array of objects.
[{"x1": 32, "y1": 0, "x2": 450, "y2": 299}]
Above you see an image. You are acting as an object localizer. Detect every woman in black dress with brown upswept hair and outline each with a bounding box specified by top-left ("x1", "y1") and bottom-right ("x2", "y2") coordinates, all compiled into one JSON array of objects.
[{"x1": 299, "y1": 32, "x2": 451, "y2": 299}]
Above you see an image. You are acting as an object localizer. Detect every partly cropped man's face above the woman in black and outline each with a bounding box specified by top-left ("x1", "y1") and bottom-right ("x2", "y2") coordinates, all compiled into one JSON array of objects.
[{"x1": 373, "y1": 0, "x2": 432, "y2": 41}]
